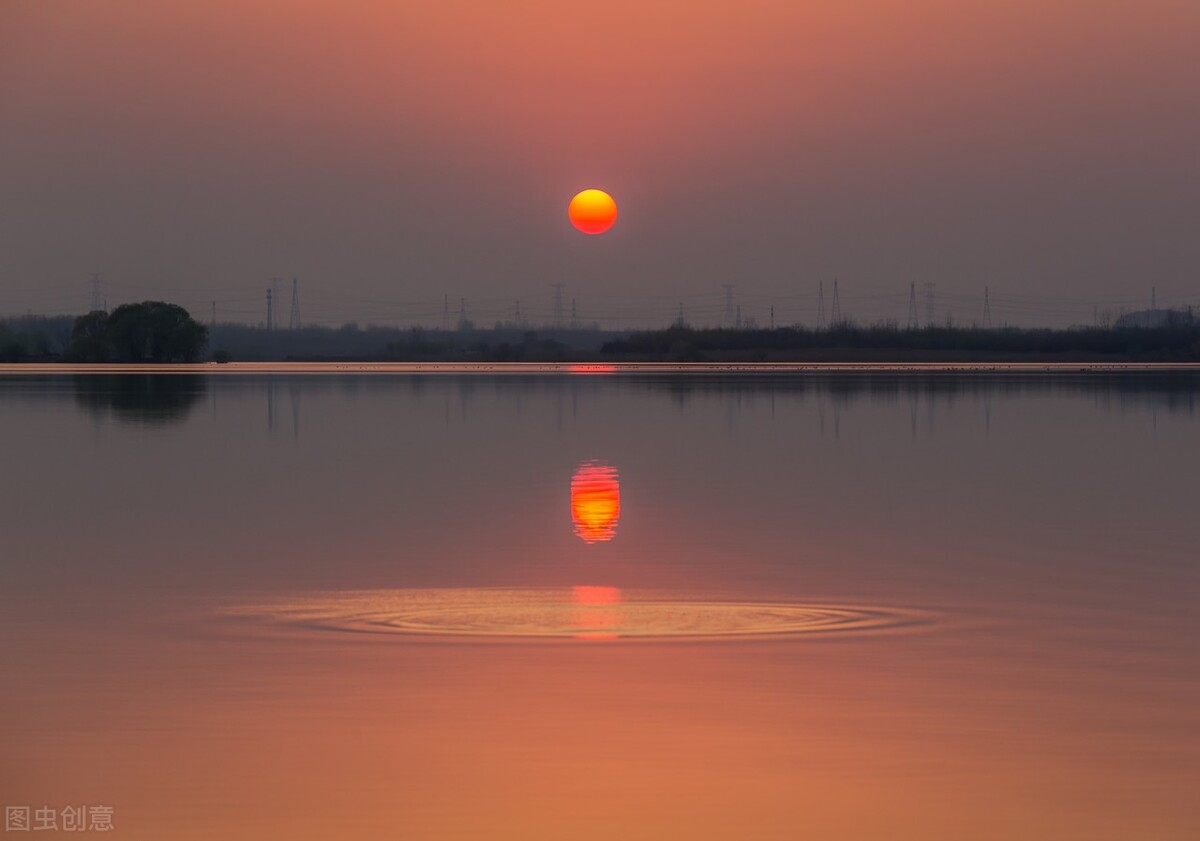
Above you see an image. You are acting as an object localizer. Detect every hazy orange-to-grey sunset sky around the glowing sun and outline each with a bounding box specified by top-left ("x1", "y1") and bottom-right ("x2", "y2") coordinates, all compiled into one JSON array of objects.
[{"x1": 0, "y1": 0, "x2": 1200, "y2": 326}]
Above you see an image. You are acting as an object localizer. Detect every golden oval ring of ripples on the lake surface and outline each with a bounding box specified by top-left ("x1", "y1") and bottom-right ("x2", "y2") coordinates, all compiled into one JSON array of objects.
[{"x1": 232, "y1": 588, "x2": 928, "y2": 639}]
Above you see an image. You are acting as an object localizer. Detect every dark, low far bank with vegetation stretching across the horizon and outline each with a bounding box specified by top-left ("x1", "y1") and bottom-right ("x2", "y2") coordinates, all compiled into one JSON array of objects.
[{"x1": 0, "y1": 302, "x2": 1200, "y2": 366}]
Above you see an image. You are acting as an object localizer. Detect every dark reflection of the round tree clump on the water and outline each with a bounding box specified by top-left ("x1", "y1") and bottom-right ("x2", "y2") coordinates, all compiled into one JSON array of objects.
[{"x1": 72, "y1": 374, "x2": 208, "y2": 423}]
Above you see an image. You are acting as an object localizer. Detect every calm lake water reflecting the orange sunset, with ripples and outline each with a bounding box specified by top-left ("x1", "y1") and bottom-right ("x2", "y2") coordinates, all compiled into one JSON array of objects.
[{"x1": 0, "y1": 374, "x2": 1200, "y2": 841}]
